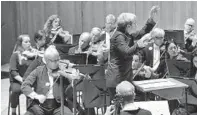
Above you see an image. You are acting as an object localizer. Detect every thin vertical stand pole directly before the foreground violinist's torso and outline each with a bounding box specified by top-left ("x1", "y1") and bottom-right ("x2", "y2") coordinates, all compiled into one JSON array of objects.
[{"x1": 60, "y1": 76, "x2": 64, "y2": 115}]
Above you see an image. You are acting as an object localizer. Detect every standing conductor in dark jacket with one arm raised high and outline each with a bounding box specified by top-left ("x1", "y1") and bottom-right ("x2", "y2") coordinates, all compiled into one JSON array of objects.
[{"x1": 106, "y1": 6, "x2": 159, "y2": 98}]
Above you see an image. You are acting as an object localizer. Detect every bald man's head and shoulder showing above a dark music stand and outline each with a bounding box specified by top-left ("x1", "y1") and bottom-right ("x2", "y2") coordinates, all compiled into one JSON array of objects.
[{"x1": 68, "y1": 32, "x2": 91, "y2": 54}]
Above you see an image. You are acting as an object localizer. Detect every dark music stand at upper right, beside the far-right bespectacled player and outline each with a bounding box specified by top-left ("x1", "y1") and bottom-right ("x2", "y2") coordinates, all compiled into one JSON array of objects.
[{"x1": 164, "y1": 30, "x2": 185, "y2": 49}]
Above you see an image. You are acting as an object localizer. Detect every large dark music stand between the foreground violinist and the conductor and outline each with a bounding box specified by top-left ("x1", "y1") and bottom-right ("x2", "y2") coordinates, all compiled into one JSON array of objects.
[{"x1": 76, "y1": 65, "x2": 110, "y2": 108}]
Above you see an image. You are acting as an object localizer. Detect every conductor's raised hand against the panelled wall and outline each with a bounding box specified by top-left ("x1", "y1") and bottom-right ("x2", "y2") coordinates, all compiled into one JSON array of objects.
[{"x1": 150, "y1": 6, "x2": 160, "y2": 22}]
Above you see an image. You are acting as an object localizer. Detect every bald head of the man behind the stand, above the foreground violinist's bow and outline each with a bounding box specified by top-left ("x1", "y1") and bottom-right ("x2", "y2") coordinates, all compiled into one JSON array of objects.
[{"x1": 79, "y1": 32, "x2": 91, "y2": 49}]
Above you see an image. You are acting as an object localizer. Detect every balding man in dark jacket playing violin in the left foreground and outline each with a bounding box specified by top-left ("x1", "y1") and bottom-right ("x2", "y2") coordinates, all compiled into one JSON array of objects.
[{"x1": 21, "y1": 47, "x2": 79, "y2": 115}]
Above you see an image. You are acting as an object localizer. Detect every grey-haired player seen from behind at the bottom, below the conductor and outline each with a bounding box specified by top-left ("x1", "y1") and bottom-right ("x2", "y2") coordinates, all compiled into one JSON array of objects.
[{"x1": 105, "y1": 81, "x2": 152, "y2": 115}]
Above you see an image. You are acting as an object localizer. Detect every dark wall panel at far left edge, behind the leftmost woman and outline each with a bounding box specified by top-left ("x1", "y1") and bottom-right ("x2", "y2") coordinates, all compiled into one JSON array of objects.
[{"x1": 1, "y1": 1, "x2": 16, "y2": 65}]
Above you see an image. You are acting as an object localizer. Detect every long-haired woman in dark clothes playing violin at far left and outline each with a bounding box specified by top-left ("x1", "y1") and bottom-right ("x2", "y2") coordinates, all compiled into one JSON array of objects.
[{"x1": 10, "y1": 35, "x2": 32, "y2": 115}]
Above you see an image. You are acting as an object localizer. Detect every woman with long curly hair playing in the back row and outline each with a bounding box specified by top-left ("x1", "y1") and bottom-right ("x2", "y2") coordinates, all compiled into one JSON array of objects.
[{"x1": 43, "y1": 15, "x2": 71, "y2": 44}]
